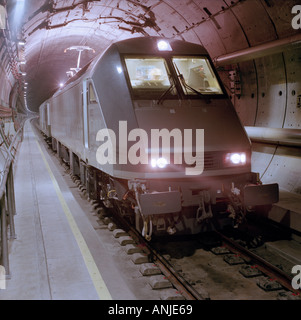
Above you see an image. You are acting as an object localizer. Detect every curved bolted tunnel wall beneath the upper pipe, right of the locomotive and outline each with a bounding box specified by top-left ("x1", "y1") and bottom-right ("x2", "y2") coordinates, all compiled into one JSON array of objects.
[{"x1": 230, "y1": 49, "x2": 301, "y2": 194}]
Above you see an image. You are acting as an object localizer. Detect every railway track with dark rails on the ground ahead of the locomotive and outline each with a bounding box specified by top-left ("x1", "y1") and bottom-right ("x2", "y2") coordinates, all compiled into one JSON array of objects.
[{"x1": 97, "y1": 200, "x2": 301, "y2": 300}]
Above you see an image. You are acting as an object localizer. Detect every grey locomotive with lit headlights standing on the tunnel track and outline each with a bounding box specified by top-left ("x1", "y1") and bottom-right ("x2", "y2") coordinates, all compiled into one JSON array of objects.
[{"x1": 39, "y1": 37, "x2": 278, "y2": 240}]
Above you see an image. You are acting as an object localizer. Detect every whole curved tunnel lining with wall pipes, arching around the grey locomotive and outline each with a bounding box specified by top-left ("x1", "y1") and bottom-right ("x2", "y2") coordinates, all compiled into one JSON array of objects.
[{"x1": 0, "y1": 0, "x2": 301, "y2": 300}]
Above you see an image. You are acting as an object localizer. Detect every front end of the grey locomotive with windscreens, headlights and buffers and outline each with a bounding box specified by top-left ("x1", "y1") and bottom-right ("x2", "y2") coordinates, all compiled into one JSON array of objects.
[{"x1": 92, "y1": 38, "x2": 278, "y2": 238}]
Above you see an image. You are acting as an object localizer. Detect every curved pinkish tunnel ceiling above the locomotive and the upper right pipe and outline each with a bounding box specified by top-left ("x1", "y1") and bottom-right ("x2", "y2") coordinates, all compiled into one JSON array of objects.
[{"x1": 7, "y1": 0, "x2": 298, "y2": 111}]
